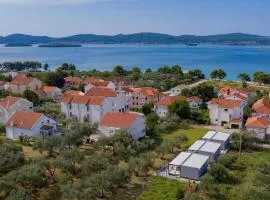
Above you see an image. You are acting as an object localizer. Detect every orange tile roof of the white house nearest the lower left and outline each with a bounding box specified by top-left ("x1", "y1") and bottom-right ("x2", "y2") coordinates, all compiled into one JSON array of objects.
[{"x1": 6, "y1": 111, "x2": 43, "y2": 129}]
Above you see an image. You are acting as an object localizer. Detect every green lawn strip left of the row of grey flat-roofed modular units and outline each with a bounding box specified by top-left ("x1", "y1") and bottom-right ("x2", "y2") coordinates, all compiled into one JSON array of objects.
[{"x1": 162, "y1": 128, "x2": 209, "y2": 147}]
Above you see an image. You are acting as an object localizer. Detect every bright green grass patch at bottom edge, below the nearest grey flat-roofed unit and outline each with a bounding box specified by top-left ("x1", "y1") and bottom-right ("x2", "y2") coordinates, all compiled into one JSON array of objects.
[{"x1": 138, "y1": 177, "x2": 186, "y2": 200}]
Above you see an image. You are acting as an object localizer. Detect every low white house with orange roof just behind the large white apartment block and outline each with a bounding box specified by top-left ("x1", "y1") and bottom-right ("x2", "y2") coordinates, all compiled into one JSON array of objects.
[{"x1": 84, "y1": 77, "x2": 115, "y2": 92}]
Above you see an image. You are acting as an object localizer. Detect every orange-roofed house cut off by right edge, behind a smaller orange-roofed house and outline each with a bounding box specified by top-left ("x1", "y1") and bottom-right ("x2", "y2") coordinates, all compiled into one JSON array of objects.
[{"x1": 252, "y1": 97, "x2": 270, "y2": 122}]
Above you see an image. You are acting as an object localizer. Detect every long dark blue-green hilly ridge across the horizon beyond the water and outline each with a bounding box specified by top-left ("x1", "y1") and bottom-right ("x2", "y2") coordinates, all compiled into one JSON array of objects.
[{"x1": 0, "y1": 33, "x2": 270, "y2": 45}]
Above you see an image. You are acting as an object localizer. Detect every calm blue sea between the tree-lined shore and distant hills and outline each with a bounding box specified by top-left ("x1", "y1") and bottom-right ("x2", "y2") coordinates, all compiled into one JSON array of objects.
[{"x1": 0, "y1": 44, "x2": 270, "y2": 80}]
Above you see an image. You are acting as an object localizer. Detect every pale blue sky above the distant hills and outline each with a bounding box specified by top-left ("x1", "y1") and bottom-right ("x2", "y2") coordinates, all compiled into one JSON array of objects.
[{"x1": 0, "y1": 0, "x2": 270, "y2": 37}]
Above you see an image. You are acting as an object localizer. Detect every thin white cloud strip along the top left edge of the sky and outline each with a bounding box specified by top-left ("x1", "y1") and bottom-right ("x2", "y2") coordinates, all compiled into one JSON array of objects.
[{"x1": 0, "y1": 0, "x2": 113, "y2": 5}]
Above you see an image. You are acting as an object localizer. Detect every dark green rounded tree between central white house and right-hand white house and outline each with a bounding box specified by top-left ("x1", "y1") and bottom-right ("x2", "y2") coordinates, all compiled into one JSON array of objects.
[{"x1": 169, "y1": 100, "x2": 190, "y2": 119}]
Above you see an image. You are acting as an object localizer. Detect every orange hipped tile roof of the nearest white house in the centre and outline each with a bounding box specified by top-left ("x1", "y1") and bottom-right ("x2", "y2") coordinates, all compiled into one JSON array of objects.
[{"x1": 99, "y1": 112, "x2": 140, "y2": 129}]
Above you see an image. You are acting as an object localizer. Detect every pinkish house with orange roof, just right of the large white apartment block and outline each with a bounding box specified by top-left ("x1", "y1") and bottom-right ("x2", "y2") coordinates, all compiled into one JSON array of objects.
[{"x1": 129, "y1": 87, "x2": 160, "y2": 108}]
